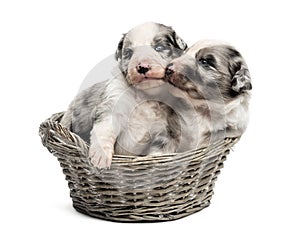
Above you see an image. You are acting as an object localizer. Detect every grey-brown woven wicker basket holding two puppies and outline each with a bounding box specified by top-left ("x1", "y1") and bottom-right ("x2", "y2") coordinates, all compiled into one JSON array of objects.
[{"x1": 39, "y1": 113, "x2": 239, "y2": 222}]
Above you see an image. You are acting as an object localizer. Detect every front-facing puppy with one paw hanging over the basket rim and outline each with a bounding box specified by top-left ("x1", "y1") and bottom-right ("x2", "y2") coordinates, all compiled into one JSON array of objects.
[{"x1": 61, "y1": 23, "x2": 187, "y2": 168}]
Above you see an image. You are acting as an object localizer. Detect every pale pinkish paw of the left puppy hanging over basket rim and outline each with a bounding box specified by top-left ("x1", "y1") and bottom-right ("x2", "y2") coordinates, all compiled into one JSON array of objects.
[{"x1": 89, "y1": 144, "x2": 114, "y2": 168}]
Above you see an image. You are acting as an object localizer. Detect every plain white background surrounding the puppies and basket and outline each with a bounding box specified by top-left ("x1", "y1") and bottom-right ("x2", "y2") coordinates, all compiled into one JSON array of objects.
[{"x1": 0, "y1": 0, "x2": 300, "y2": 232}]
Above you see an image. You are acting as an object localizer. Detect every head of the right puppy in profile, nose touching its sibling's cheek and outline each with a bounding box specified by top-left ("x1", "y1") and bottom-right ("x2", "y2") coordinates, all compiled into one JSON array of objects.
[{"x1": 166, "y1": 41, "x2": 252, "y2": 101}]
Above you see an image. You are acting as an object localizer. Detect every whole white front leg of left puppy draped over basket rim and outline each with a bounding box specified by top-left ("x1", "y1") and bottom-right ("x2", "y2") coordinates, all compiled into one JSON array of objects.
[{"x1": 89, "y1": 120, "x2": 116, "y2": 168}]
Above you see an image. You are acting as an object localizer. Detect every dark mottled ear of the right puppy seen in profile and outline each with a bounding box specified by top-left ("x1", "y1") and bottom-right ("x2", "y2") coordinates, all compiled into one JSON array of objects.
[{"x1": 231, "y1": 62, "x2": 252, "y2": 93}]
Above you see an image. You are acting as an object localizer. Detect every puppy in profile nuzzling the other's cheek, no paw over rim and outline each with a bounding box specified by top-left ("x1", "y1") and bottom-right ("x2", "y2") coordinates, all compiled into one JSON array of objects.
[{"x1": 166, "y1": 41, "x2": 252, "y2": 149}]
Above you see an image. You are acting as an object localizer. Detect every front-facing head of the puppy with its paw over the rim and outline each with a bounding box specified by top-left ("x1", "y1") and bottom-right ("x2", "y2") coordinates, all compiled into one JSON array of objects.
[{"x1": 115, "y1": 22, "x2": 187, "y2": 85}]
